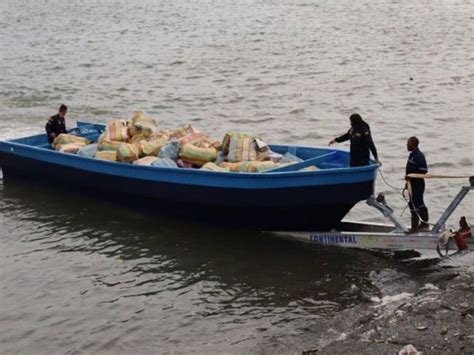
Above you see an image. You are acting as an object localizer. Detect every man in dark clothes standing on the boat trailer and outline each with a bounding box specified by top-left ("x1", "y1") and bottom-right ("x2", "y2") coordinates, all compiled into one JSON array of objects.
[{"x1": 405, "y1": 137, "x2": 429, "y2": 231}]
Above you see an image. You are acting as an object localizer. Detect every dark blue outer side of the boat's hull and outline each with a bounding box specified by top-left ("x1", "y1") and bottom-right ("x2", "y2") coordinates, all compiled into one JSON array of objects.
[{"x1": 0, "y1": 149, "x2": 373, "y2": 231}]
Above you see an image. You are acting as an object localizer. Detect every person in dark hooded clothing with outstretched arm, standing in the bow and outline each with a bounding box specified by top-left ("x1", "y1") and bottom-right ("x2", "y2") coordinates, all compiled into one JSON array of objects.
[{"x1": 329, "y1": 113, "x2": 382, "y2": 166}]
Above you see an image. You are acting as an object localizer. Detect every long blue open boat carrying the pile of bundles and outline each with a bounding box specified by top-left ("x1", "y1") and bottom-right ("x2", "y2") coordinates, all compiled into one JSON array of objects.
[{"x1": 0, "y1": 122, "x2": 377, "y2": 231}]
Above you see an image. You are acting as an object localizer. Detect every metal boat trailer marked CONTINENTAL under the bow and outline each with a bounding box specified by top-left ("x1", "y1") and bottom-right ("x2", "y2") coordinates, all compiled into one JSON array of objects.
[{"x1": 274, "y1": 176, "x2": 474, "y2": 257}]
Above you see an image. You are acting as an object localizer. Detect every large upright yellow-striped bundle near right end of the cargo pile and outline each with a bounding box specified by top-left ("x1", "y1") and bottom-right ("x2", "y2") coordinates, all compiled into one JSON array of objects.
[{"x1": 222, "y1": 132, "x2": 269, "y2": 163}]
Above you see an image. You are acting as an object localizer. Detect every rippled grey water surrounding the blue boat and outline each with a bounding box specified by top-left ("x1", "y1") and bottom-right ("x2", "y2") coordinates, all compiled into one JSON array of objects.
[{"x1": 0, "y1": 0, "x2": 474, "y2": 354}]
